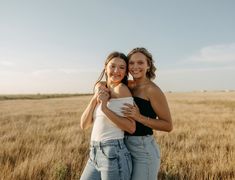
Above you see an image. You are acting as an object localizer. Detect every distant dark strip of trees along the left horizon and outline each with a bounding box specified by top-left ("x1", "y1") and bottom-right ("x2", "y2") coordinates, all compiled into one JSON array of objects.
[{"x1": 0, "y1": 93, "x2": 91, "y2": 101}]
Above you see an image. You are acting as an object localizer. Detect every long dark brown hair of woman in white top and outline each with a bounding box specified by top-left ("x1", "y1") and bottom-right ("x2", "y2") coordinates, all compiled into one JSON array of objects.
[{"x1": 94, "y1": 51, "x2": 128, "y2": 87}]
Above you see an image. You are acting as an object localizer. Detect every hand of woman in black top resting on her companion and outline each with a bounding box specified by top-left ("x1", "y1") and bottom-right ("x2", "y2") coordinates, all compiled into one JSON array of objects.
[{"x1": 122, "y1": 103, "x2": 141, "y2": 121}]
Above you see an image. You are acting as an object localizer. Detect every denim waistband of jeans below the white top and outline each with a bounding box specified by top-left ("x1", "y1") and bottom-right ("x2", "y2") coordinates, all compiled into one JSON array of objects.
[{"x1": 90, "y1": 139, "x2": 125, "y2": 149}]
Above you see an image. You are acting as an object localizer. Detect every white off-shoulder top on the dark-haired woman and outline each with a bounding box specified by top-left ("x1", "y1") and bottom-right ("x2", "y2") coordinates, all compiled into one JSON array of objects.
[{"x1": 91, "y1": 97, "x2": 134, "y2": 141}]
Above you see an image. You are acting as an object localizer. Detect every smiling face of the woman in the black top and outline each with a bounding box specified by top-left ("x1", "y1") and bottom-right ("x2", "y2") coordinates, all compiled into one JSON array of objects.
[{"x1": 128, "y1": 52, "x2": 149, "y2": 79}]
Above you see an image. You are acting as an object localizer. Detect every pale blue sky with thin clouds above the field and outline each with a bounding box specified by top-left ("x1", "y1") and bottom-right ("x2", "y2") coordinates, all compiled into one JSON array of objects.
[{"x1": 0, "y1": 0, "x2": 235, "y2": 94}]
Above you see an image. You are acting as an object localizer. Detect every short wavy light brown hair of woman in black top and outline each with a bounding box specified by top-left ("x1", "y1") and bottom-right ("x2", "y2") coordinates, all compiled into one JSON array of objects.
[{"x1": 127, "y1": 47, "x2": 156, "y2": 79}]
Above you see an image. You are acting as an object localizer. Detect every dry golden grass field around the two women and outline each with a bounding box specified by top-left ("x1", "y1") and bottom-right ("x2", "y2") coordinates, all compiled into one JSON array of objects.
[{"x1": 0, "y1": 92, "x2": 235, "y2": 180}]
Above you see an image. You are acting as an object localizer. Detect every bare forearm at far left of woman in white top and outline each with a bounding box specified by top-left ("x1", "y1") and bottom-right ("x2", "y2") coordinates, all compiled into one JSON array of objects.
[{"x1": 80, "y1": 94, "x2": 97, "y2": 129}]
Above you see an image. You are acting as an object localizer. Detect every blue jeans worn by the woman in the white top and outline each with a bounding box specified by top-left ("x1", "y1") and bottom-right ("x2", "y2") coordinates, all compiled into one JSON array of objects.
[{"x1": 80, "y1": 139, "x2": 132, "y2": 180}]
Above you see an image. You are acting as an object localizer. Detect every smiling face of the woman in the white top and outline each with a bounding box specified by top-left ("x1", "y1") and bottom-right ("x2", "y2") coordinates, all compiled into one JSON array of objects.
[{"x1": 105, "y1": 57, "x2": 127, "y2": 83}]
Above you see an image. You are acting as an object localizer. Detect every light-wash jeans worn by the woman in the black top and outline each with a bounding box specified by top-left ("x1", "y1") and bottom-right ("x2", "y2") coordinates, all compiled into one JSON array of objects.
[{"x1": 125, "y1": 135, "x2": 160, "y2": 180}]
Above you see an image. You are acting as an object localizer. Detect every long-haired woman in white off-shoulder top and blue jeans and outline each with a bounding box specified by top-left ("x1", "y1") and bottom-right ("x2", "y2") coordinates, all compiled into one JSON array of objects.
[{"x1": 81, "y1": 52, "x2": 135, "y2": 180}]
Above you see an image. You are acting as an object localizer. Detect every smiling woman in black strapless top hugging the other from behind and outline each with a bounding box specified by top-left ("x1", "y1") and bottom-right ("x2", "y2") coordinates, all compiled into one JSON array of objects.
[{"x1": 123, "y1": 48, "x2": 172, "y2": 180}]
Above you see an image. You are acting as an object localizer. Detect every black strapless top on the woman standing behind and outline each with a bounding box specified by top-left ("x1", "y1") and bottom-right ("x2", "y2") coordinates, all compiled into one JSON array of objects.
[{"x1": 125, "y1": 97, "x2": 157, "y2": 136}]
